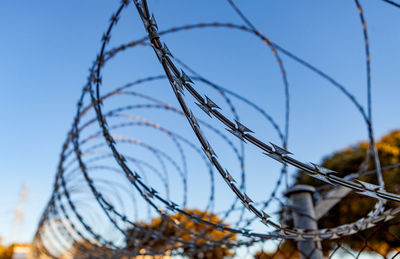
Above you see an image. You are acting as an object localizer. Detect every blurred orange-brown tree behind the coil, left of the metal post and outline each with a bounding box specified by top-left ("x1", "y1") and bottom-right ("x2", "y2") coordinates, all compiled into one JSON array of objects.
[{"x1": 126, "y1": 209, "x2": 236, "y2": 259}]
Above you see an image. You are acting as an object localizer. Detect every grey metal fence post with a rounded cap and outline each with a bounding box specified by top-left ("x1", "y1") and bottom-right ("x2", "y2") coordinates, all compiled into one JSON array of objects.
[{"x1": 285, "y1": 184, "x2": 323, "y2": 259}]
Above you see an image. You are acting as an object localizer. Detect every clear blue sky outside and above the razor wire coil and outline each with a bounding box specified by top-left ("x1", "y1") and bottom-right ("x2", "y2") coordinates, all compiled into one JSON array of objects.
[{"x1": 0, "y1": 0, "x2": 400, "y2": 247}]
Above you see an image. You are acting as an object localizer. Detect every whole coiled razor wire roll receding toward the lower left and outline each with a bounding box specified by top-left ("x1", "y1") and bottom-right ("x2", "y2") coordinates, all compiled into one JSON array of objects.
[{"x1": 33, "y1": 0, "x2": 400, "y2": 258}]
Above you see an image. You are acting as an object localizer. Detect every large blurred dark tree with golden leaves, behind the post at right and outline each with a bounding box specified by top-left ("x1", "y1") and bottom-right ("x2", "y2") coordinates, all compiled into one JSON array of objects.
[{"x1": 255, "y1": 130, "x2": 400, "y2": 258}]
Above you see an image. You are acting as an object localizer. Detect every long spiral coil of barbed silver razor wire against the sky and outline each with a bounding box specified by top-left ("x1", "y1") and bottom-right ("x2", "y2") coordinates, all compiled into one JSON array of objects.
[{"x1": 33, "y1": 0, "x2": 400, "y2": 258}]
